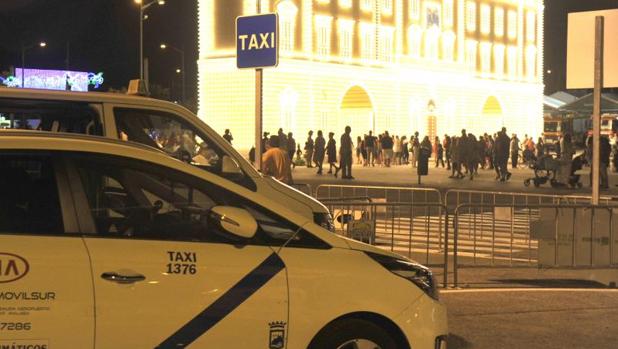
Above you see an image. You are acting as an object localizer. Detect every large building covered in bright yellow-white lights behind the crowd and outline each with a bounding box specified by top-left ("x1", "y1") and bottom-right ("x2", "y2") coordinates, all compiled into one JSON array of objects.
[{"x1": 198, "y1": 0, "x2": 544, "y2": 149}]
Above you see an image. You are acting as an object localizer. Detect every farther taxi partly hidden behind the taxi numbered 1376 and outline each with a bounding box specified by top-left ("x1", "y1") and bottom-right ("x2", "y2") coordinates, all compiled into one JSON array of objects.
[{"x1": 0, "y1": 88, "x2": 333, "y2": 230}]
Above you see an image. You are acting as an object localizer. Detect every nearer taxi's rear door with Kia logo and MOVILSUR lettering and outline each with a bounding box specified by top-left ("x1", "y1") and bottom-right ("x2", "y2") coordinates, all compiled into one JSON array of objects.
[{"x1": 0, "y1": 153, "x2": 94, "y2": 348}]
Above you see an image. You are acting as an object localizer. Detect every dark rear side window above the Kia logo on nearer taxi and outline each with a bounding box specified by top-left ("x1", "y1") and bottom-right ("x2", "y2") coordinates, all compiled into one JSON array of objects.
[{"x1": 0, "y1": 154, "x2": 64, "y2": 234}]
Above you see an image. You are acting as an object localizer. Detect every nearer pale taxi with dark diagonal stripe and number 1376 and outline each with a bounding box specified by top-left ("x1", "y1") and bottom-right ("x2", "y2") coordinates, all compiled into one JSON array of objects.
[{"x1": 0, "y1": 131, "x2": 448, "y2": 349}]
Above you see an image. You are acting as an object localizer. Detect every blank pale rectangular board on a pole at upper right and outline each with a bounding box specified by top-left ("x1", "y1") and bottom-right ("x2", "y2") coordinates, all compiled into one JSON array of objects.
[{"x1": 567, "y1": 9, "x2": 618, "y2": 89}]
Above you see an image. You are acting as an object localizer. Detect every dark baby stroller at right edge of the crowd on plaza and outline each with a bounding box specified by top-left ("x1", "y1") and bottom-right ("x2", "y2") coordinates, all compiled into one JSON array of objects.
[{"x1": 524, "y1": 153, "x2": 584, "y2": 188}]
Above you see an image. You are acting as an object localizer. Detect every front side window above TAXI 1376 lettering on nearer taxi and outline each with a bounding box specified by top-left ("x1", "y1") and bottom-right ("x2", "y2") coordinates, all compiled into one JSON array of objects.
[{"x1": 77, "y1": 161, "x2": 220, "y2": 241}]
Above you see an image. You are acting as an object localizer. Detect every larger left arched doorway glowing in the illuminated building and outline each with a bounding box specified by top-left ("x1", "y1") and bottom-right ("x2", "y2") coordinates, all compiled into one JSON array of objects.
[{"x1": 335, "y1": 86, "x2": 375, "y2": 137}]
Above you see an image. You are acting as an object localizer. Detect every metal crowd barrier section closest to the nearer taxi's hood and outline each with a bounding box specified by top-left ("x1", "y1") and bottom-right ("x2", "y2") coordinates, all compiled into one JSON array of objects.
[{"x1": 323, "y1": 197, "x2": 449, "y2": 287}]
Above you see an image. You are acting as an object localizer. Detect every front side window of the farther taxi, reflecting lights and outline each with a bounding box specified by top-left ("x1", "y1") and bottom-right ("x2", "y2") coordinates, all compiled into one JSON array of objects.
[{"x1": 114, "y1": 108, "x2": 223, "y2": 173}]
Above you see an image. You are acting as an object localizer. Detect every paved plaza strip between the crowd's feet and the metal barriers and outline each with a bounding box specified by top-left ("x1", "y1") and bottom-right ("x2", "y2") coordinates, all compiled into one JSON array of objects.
[{"x1": 293, "y1": 160, "x2": 618, "y2": 195}]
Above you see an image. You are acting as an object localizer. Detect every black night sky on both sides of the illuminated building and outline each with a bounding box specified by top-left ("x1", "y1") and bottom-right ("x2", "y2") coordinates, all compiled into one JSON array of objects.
[{"x1": 0, "y1": 0, "x2": 618, "y2": 98}]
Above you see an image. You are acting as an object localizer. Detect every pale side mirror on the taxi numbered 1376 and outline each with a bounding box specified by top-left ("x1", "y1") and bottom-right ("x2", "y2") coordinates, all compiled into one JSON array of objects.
[{"x1": 208, "y1": 206, "x2": 258, "y2": 240}]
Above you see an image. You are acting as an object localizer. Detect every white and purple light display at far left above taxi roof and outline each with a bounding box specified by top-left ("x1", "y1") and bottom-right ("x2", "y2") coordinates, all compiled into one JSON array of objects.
[{"x1": 0, "y1": 68, "x2": 104, "y2": 91}]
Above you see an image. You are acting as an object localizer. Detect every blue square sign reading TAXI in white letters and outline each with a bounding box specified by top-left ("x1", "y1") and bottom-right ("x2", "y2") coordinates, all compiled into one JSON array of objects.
[{"x1": 236, "y1": 13, "x2": 279, "y2": 69}]
